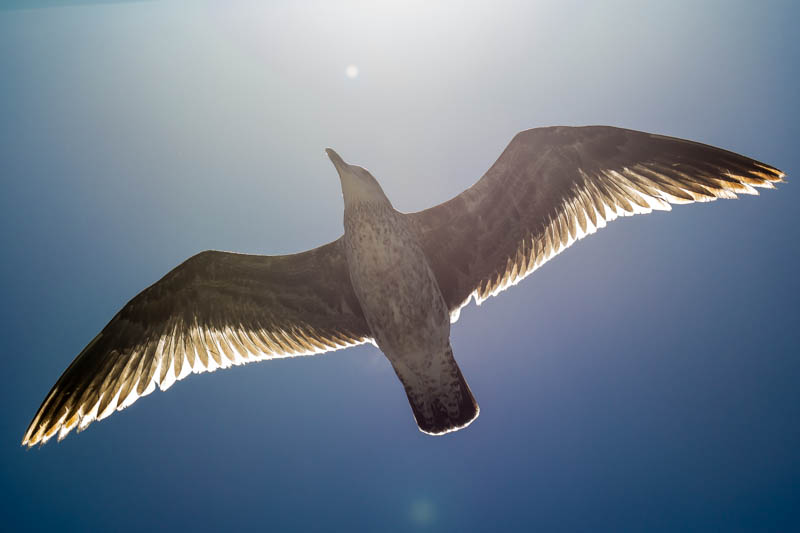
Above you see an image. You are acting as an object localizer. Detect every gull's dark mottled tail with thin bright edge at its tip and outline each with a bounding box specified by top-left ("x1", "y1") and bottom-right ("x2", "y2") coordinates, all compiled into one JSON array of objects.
[{"x1": 392, "y1": 344, "x2": 480, "y2": 435}]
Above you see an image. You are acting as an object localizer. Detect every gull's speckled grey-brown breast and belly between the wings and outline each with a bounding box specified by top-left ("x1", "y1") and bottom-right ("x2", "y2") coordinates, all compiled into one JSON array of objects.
[{"x1": 345, "y1": 208, "x2": 450, "y2": 358}]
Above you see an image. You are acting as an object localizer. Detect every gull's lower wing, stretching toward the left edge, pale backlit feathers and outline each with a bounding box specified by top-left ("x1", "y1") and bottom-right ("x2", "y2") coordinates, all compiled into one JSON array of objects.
[{"x1": 22, "y1": 239, "x2": 370, "y2": 446}]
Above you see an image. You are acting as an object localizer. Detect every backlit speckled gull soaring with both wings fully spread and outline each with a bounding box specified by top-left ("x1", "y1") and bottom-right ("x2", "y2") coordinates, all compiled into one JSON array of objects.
[{"x1": 22, "y1": 126, "x2": 785, "y2": 447}]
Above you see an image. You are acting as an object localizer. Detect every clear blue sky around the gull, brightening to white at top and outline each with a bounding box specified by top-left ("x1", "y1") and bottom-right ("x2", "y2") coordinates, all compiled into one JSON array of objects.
[{"x1": 0, "y1": 0, "x2": 800, "y2": 532}]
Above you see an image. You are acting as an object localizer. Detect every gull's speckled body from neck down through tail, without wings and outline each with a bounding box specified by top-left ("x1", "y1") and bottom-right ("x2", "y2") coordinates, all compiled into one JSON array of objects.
[{"x1": 344, "y1": 202, "x2": 478, "y2": 434}]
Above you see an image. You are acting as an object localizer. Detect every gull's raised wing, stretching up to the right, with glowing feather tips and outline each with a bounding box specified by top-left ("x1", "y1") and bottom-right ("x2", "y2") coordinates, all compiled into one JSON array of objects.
[{"x1": 409, "y1": 126, "x2": 784, "y2": 320}]
